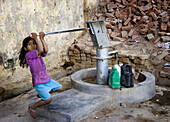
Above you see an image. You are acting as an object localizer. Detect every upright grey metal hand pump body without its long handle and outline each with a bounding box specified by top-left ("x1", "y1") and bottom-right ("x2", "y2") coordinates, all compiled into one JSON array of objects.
[{"x1": 87, "y1": 20, "x2": 111, "y2": 85}]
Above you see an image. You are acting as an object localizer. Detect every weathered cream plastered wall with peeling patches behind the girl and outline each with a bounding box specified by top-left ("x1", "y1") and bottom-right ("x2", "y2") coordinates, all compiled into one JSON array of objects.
[{"x1": 0, "y1": 0, "x2": 97, "y2": 101}]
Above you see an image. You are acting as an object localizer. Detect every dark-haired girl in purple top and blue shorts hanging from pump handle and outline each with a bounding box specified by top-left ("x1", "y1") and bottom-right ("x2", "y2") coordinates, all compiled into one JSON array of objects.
[{"x1": 19, "y1": 32, "x2": 62, "y2": 119}]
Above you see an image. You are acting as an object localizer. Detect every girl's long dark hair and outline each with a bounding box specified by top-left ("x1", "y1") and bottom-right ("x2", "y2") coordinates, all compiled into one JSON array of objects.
[{"x1": 19, "y1": 36, "x2": 35, "y2": 68}]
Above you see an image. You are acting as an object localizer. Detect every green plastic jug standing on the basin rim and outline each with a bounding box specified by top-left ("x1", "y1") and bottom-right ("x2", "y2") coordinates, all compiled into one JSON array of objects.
[{"x1": 109, "y1": 66, "x2": 120, "y2": 89}]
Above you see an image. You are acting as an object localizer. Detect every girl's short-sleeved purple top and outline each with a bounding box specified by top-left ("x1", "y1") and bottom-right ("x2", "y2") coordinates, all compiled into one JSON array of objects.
[{"x1": 25, "y1": 50, "x2": 50, "y2": 86}]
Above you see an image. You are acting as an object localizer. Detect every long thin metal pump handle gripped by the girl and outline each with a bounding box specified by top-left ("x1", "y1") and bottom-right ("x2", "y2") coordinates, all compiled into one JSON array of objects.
[{"x1": 30, "y1": 27, "x2": 90, "y2": 36}]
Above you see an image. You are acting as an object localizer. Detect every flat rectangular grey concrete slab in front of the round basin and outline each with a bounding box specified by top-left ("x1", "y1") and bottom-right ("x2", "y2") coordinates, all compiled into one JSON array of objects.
[{"x1": 36, "y1": 89, "x2": 111, "y2": 122}]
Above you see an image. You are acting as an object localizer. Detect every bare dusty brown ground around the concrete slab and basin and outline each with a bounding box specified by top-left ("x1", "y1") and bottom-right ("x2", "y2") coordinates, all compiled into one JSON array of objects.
[{"x1": 0, "y1": 76, "x2": 170, "y2": 122}]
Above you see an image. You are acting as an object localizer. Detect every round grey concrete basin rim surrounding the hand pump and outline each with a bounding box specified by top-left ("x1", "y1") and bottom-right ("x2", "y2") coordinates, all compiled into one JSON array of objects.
[{"x1": 71, "y1": 68, "x2": 155, "y2": 103}]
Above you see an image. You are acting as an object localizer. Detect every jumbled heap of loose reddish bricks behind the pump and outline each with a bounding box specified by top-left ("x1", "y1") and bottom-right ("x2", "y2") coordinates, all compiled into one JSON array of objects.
[{"x1": 94, "y1": 0, "x2": 170, "y2": 43}]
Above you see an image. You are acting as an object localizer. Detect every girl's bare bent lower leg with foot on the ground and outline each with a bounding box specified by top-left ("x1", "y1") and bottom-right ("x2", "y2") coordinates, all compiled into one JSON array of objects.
[{"x1": 28, "y1": 97, "x2": 52, "y2": 119}]
